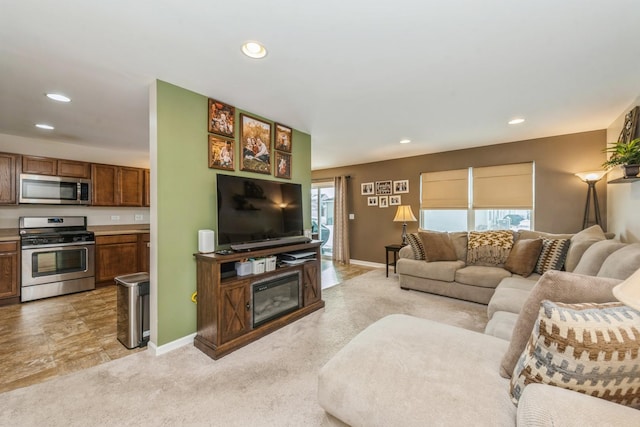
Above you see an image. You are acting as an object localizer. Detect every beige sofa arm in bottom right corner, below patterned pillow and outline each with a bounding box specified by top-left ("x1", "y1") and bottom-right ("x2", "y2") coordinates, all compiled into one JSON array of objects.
[{"x1": 517, "y1": 384, "x2": 640, "y2": 427}]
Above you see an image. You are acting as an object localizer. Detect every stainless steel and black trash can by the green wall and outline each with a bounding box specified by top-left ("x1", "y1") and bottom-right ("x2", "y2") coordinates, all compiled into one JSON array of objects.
[{"x1": 115, "y1": 273, "x2": 149, "y2": 348}]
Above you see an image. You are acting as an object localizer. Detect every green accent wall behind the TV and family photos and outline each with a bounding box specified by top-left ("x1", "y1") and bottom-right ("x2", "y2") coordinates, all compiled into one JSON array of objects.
[{"x1": 158, "y1": 80, "x2": 311, "y2": 346}]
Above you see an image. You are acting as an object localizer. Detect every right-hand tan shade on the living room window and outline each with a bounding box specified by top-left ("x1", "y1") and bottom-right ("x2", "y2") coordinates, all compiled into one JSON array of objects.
[{"x1": 472, "y1": 163, "x2": 533, "y2": 209}]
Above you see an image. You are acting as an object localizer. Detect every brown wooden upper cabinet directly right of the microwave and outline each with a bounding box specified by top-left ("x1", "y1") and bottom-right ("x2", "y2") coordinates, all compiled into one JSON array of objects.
[{"x1": 91, "y1": 164, "x2": 144, "y2": 206}]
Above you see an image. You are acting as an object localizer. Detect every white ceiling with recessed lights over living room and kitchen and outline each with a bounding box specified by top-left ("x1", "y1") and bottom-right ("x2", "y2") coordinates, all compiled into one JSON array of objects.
[{"x1": 0, "y1": 0, "x2": 640, "y2": 169}]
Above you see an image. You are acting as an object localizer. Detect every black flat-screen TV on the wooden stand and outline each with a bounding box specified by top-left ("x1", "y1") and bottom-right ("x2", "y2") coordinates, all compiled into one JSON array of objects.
[{"x1": 217, "y1": 174, "x2": 304, "y2": 246}]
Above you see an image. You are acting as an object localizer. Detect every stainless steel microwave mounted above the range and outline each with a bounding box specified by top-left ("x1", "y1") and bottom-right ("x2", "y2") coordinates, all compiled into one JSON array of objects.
[{"x1": 19, "y1": 173, "x2": 91, "y2": 205}]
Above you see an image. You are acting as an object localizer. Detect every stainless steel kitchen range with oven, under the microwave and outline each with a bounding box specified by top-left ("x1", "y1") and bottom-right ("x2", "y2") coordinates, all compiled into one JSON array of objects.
[{"x1": 19, "y1": 216, "x2": 96, "y2": 302}]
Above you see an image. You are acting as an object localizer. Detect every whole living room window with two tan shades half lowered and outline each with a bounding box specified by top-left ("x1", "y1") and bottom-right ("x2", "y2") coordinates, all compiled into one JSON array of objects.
[{"x1": 420, "y1": 163, "x2": 534, "y2": 231}]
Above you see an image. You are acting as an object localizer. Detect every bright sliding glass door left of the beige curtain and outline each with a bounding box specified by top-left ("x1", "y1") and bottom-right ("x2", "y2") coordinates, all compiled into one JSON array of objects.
[{"x1": 311, "y1": 181, "x2": 335, "y2": 257}]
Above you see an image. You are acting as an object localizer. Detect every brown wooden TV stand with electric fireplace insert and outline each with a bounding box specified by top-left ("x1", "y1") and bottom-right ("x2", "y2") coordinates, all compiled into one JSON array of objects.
[{"x1": 193, "y1": 241, "x2": 324, "y2": 359}]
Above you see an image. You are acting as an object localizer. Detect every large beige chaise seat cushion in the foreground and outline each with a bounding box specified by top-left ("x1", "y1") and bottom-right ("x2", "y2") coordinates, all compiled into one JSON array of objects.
[{"x1": 318, "y1": 314, "x2": 516, "y2": 426}]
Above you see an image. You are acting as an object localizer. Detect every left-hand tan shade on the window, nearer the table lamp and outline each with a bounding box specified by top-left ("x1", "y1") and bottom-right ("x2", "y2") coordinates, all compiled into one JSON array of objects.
[{"x1": 420, "y1": 169, "x2": 469, "y2": 209}]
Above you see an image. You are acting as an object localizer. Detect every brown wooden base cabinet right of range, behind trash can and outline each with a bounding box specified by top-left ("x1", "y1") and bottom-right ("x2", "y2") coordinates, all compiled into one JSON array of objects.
[{"x1": 95, "y1": 234, "x2": 140, "y2": 285}]
